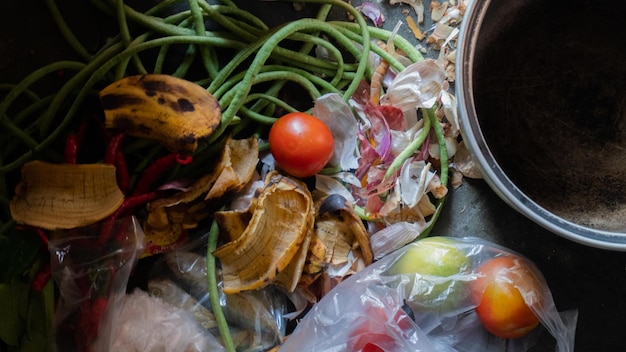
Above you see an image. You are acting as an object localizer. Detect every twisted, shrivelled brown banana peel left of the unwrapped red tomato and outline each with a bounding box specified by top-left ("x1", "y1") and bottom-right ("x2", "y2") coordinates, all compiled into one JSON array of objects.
[{"x1": 144, "y1": 137, "x2": 259, "y2": 252}]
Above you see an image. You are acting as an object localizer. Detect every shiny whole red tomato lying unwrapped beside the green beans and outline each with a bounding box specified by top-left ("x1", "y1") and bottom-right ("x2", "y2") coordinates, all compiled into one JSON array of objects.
[{"x1": 269, "y1": 112, "x2": 335, "y2": 177}]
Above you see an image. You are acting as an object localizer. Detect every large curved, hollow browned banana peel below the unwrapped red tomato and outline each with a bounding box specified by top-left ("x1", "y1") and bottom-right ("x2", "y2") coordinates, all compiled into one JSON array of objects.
[{"x1": 213, "y1": 173, "x2": 315, "y2": 293}]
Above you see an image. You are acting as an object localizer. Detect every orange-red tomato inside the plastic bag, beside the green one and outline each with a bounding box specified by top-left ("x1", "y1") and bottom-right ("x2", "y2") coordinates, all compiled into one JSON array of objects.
[{"x1": 472, "y1": 256, "x2": 542, "y2": 339}]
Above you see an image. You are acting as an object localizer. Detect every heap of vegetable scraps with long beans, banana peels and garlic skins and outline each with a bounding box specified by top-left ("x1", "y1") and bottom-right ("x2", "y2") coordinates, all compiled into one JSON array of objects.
[{"x1": 0, "y1": 0, "x2": 467, "y2": 350}]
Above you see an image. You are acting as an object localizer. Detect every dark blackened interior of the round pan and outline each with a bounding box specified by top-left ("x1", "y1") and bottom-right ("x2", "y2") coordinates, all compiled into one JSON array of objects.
[{"x1": 472, "y1": 0, "x2": 626, "y2": 233}]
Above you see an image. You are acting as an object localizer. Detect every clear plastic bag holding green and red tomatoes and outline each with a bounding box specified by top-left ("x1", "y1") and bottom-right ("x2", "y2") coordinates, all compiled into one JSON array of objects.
[{"x1": 280, "y1": 236, "x2": 578, "y2": 352}]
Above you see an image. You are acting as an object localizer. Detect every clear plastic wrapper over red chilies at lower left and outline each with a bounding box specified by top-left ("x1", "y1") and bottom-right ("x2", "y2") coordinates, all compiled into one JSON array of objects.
[{"x1": 48, "y1": 217, "x2": 145, "y2": 352}]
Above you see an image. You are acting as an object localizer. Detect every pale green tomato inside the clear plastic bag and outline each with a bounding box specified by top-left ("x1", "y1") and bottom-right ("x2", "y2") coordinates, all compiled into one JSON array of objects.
[{"x1": 389, "y1": 237, "x2": 470, "y2": 311}]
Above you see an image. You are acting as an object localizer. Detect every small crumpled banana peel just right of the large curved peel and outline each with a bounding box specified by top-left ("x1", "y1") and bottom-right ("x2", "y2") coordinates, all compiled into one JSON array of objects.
[{"x1": 299, "y1": 194, "x2": 374, "y2": 286}]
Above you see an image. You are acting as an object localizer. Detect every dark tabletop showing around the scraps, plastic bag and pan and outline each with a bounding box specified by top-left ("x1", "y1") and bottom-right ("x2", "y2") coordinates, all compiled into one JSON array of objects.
[{"x1": 0, "y1": 0, "x2": 626, "y2": 351}]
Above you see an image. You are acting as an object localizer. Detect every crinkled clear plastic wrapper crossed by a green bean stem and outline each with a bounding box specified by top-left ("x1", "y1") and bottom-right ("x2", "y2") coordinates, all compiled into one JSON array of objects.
[{"x1": 147, "y1": 247, "x2": 287, "y2": 352}]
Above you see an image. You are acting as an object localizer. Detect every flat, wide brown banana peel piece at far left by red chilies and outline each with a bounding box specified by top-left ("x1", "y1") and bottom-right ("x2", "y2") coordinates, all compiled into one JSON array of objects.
[{"x1": 10, "y1": 161, "x2": 124, "y2": 230}]
